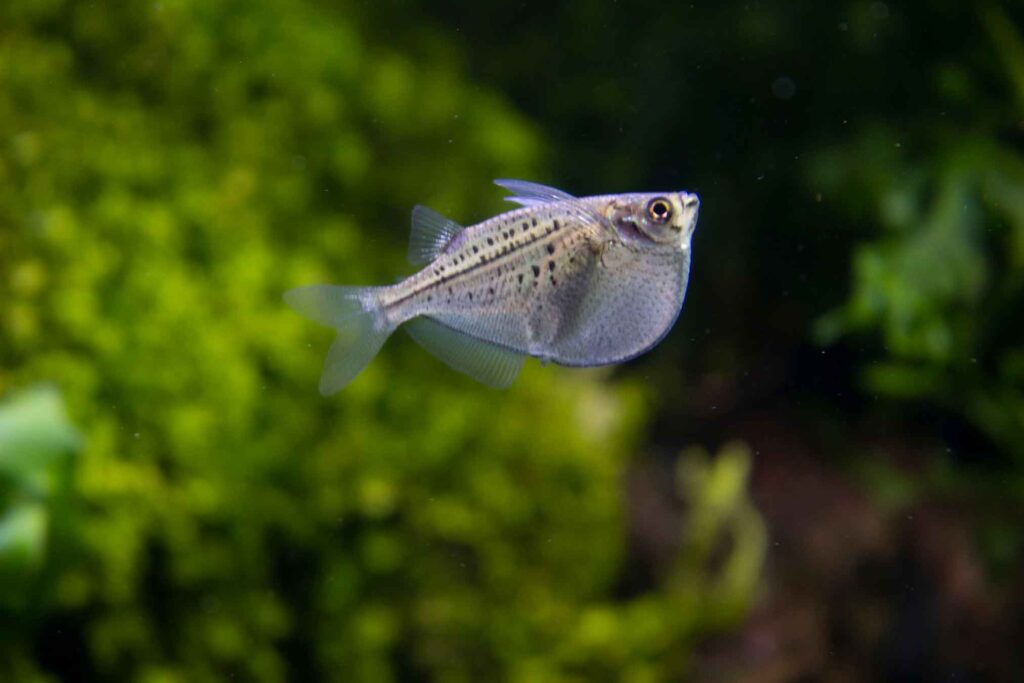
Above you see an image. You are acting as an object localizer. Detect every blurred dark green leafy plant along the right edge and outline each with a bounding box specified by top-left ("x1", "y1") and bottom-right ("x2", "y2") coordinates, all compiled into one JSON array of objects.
[{"x1": 811, "y1": 7, "x2": 1024, "y2": 577}]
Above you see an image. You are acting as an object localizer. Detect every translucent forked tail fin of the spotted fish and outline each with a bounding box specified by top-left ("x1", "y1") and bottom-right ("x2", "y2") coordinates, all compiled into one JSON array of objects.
[{"x1": 285, "y1": 285, "x2": 394, "y2": 396}]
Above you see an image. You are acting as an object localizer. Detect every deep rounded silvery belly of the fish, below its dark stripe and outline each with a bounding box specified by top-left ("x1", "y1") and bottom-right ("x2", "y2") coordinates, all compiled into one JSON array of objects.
[{"x1": 395, "y1": 235, "x2": 689, "y2": 366}]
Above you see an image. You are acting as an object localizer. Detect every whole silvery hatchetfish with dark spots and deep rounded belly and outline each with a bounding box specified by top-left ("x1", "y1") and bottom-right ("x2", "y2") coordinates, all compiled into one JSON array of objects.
[{"x1": 285, "y1": 180, "x2": 700, "y2": 395}]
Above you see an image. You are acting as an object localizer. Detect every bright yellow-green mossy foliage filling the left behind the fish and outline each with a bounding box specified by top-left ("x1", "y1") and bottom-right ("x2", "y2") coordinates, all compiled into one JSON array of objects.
[{"x1": 0, "y1": 0, "x2": 764, "y2": 683}]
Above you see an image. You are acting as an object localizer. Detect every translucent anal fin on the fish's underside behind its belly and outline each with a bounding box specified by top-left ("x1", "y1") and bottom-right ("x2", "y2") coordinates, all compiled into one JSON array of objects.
[{"x1": 404, "y1": 316, "x2": 526, "y2": 388}]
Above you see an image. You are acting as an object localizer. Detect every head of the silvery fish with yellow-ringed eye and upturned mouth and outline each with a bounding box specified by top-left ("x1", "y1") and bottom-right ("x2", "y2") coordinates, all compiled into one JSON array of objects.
[{"x1": 605, "y1": 191, "x2": 700, "y2": 251}]
